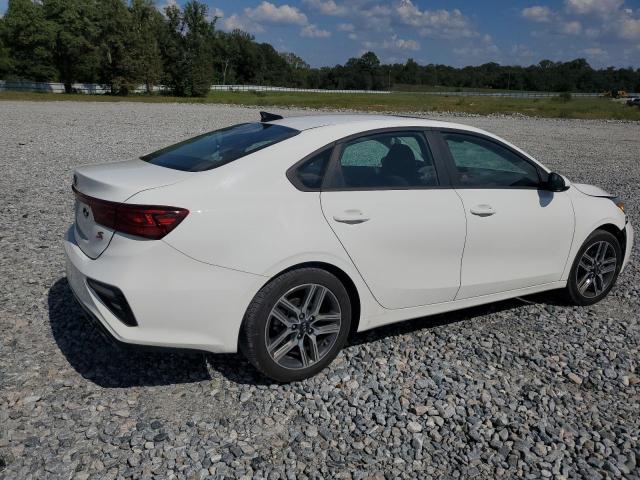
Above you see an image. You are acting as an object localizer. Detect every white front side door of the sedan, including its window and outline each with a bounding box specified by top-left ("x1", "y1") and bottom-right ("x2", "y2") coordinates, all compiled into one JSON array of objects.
[{"x1": 441, "y1": 131, "x2": 575, "y2": 299}]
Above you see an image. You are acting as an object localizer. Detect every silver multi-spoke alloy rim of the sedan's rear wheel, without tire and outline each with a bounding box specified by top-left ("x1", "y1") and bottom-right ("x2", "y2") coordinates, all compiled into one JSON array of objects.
[{"x1": 265, "y1": 284, "x2": 342, "y2": 370}]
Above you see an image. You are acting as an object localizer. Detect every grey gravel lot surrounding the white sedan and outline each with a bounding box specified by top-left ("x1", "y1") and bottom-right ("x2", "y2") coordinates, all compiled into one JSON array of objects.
[{"x1": 0, "y1": 102, "x2": 640, "y2": 479}]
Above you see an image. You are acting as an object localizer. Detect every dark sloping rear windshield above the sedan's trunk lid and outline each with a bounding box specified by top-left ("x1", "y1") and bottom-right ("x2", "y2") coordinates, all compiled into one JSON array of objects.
[{"x1": 140, "y1": 123, "x2": 299, "y2": 172}]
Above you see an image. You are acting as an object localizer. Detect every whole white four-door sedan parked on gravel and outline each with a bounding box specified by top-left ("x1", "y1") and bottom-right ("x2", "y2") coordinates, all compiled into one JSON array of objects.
[{"x1": 65, "y1": 112, "x2": 633, "y2": 381}]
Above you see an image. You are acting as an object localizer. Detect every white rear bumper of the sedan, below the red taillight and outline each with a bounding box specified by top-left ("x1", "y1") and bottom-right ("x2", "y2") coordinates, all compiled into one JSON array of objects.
[{"x1": 64, "y1": 225, "x2": 267, "y2": 353}]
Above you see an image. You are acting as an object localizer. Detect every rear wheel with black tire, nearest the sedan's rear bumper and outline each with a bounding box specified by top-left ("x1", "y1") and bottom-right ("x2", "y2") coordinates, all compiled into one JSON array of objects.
[{"x1": 240, "y1": 268, "x2": 351, "y2": 382}]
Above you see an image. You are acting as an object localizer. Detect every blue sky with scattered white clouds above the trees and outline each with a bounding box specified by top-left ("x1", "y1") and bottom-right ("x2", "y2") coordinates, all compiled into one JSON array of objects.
[{"x1": 0, "y1": 0, "x2": 640, "y2": 68}]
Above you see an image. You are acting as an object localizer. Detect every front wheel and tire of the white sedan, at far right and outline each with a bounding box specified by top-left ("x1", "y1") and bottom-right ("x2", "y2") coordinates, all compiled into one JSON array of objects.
[{"x1": 563, "y1": 230, "x2": 623, "y2": 306}]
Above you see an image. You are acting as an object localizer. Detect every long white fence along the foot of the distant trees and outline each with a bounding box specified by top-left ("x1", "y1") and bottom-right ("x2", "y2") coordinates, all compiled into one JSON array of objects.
[{"x1": 0, "y1": 80, "x2": 640, "y2": 98}]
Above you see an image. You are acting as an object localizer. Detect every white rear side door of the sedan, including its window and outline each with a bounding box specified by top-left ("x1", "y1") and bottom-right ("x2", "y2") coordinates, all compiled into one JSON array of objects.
[{"x1": 320, "y1": 131, "x2": 466, "y2": 309}]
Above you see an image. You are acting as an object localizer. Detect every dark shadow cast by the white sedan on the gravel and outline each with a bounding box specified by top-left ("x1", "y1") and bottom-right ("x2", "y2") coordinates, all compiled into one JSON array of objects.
[{"x1": 48, "y1": 278, "x2": 544, "y2": 388}]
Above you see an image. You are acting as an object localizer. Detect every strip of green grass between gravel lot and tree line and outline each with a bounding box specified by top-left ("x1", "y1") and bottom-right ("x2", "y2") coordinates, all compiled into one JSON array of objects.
[{"x1": 0, "y1": 92, "x2": 640, "y2": 121}]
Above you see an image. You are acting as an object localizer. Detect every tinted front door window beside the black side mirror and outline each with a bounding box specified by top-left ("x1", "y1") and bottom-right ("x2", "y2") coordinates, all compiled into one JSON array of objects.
[{"x1": 444, "y1": 133, "x2": 540, "y2": 187}]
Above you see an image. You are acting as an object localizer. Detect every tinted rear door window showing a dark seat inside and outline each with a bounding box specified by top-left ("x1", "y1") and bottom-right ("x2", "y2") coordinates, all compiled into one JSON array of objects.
[{"x1": 335, "y1": 132, "x2": 438, "y2": 188}]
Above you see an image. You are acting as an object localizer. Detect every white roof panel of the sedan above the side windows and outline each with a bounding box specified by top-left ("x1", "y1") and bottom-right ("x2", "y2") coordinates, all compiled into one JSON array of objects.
[{"x1": 269, "y1": 114, "x2": 485, "y2": 133}]
